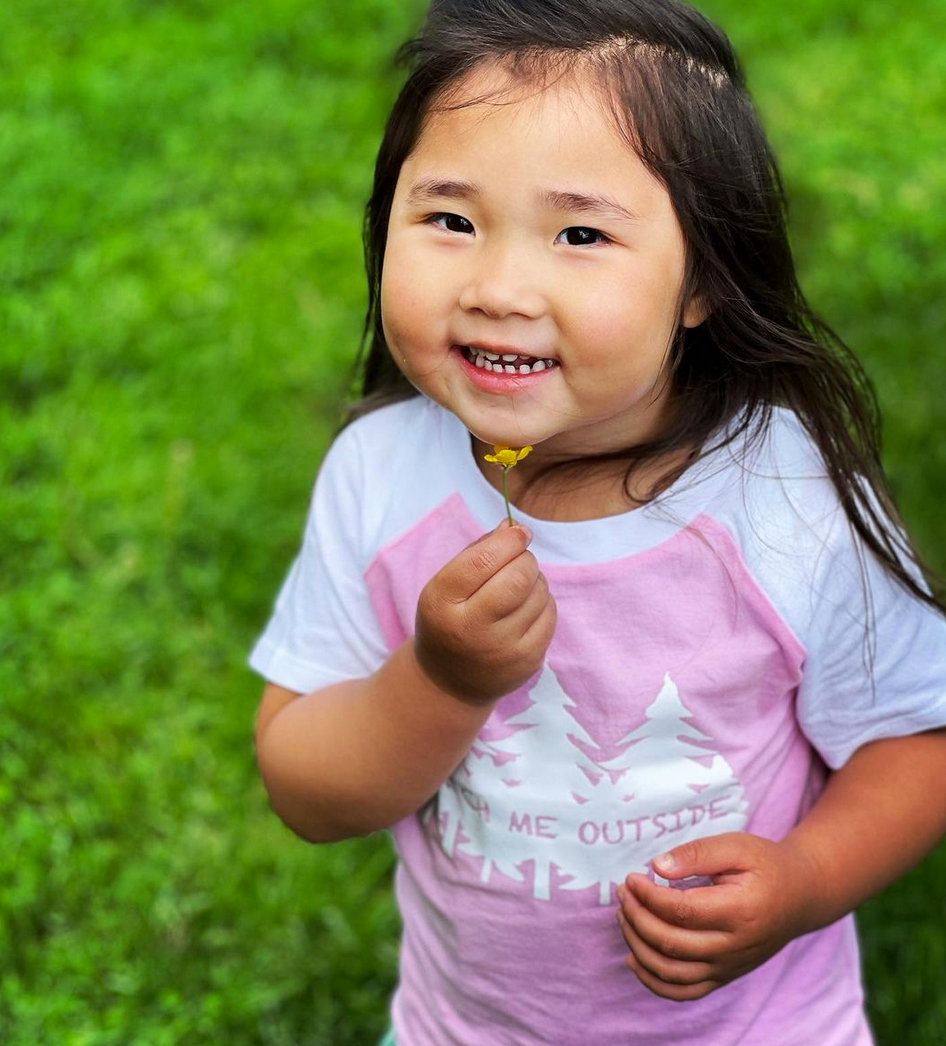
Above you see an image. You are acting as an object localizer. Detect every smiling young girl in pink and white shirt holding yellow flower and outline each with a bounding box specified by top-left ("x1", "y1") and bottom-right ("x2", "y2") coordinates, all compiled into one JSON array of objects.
[{"x1": 251, "y1": 0, "x2": 946, "y2": 1046}]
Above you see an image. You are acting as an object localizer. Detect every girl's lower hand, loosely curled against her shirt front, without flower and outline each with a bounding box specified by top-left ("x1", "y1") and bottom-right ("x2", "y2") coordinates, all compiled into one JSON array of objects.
[{"x1": 617, "y1": 832, "x2": 818, "y2": 1002}]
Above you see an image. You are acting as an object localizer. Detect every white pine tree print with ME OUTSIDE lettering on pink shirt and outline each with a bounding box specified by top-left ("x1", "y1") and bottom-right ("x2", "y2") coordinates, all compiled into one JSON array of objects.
[{"x1": 428, "y1": 665, "x2": 746, "y2": 904}]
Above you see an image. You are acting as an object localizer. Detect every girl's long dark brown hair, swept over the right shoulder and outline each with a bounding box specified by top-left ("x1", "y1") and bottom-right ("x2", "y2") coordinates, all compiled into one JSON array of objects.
[{"x1": 350, "y1": 0, "x2": 943, "y2": 610}]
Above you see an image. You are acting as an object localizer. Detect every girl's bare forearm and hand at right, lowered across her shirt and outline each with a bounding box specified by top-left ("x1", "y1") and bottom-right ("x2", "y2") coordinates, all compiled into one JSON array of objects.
[{"x1": 618, "y1": 730, "x2": 946, "y2": 1001}]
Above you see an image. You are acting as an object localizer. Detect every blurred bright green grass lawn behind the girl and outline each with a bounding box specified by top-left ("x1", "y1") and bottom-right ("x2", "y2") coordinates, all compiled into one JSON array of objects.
[{"x1": 0, "y1": 0, "x2": 946, "y2": 1046}]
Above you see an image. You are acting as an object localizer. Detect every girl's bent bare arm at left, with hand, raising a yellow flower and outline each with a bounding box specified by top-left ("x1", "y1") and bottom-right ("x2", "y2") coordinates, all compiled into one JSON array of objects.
[{"x1": 256, "y1": 527, "x2": 555, "y2": 842}]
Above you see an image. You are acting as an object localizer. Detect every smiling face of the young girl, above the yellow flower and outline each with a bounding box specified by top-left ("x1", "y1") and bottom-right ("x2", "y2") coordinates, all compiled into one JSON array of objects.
[{"x1": 381, "y1": 62, "x2": 702, "y2": 457}]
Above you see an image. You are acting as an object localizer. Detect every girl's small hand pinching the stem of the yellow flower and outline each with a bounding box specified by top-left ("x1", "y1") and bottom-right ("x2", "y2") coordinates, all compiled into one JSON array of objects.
[{"x1": 414, "y1": 523, "x2": 556, "y2": 705}]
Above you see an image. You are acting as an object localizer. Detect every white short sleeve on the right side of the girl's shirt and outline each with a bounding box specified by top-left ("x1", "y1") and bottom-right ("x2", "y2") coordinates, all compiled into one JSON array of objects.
[{"x1": 673, "y1": 410, "x2": 946, "y2": 768}]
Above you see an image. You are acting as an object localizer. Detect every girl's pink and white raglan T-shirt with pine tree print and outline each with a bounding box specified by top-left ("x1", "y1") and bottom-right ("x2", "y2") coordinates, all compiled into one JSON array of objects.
[{"x1": 250, "y1": 397, "x2": 946, "y2": 1046}]
